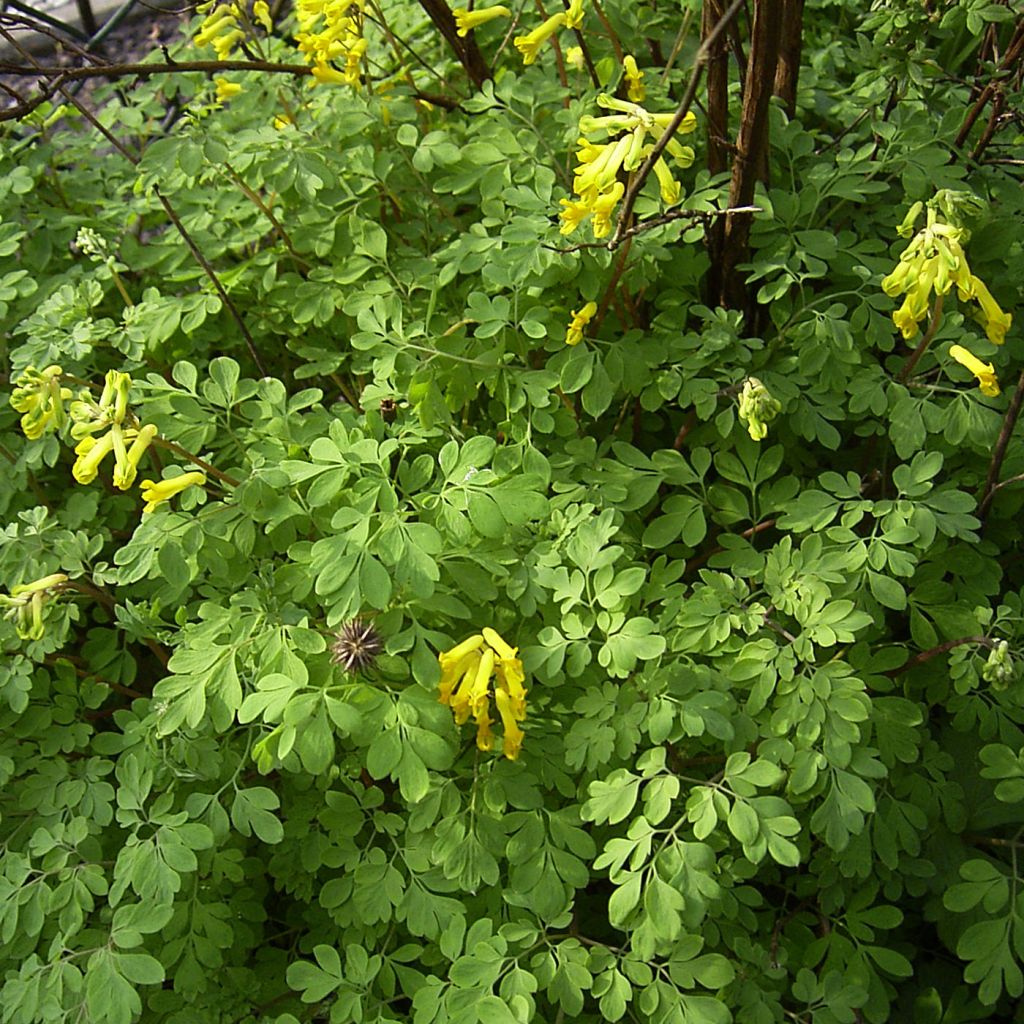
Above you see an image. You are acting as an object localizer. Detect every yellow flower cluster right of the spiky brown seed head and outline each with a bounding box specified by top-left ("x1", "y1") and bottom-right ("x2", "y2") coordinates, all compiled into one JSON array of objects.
[{"x1": 437, "y1": 627, "x2": 526, "y2": 761}]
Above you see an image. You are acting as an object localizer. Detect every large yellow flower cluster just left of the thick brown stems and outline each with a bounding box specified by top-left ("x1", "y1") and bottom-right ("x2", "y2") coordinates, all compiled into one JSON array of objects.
[{"x1": 559, "y1": 93, "x2": 697, "y2": 239}]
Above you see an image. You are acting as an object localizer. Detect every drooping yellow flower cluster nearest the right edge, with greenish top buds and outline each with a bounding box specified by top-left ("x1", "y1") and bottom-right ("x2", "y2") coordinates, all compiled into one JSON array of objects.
[{"x1": 882, "y1": 203, "x2": 1013, "y2": 345}]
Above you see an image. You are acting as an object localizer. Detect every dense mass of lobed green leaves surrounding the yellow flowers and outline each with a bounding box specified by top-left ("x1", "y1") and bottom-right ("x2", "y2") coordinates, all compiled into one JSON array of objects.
[{"x1": 0, "y1": 0, "x2": 1024, "y2": 1024}]
